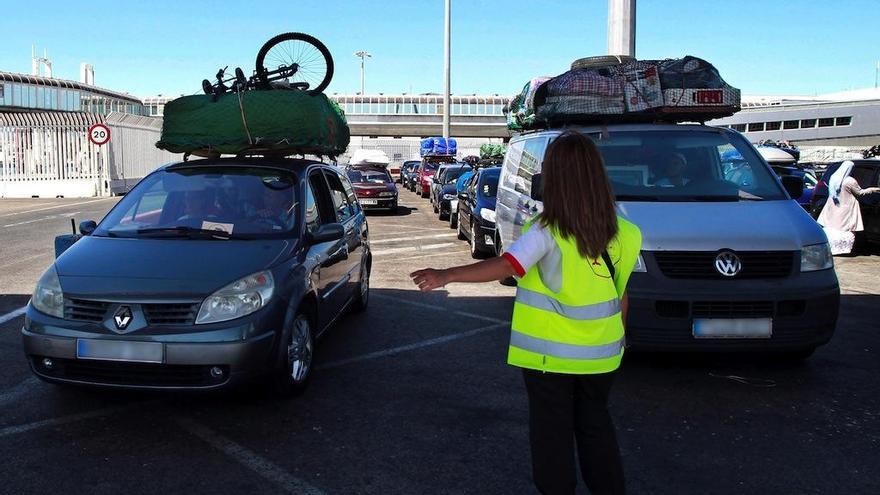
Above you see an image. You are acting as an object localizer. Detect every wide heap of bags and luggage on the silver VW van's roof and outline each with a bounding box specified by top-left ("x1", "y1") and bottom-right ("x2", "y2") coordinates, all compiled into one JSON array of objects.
[{"x1": 506, "y1": 56, "x2": 740, "y2": 131}]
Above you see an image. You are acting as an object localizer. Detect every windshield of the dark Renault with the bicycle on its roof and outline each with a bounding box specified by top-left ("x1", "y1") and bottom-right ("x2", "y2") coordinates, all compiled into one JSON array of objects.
[{"x1": 94, "y1": 167, "x2": 298, "y2": 239}]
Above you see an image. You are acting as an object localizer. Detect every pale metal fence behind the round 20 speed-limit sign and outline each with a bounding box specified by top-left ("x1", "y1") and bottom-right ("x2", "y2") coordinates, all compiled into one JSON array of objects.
[{"x1": 0, "y1": 112, "x2": 180, "y2": 197}]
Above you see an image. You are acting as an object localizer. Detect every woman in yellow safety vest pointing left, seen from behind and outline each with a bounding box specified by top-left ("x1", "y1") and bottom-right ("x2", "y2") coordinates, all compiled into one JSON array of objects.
[{"x1": 411, "y1": 131, "x2": 642, "y2": 495}]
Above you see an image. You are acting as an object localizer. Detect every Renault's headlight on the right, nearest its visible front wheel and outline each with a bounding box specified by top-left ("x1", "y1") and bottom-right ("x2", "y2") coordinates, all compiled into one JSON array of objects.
[{"x1": 196, "y1": 270, "x2": 275, "y2": 324}]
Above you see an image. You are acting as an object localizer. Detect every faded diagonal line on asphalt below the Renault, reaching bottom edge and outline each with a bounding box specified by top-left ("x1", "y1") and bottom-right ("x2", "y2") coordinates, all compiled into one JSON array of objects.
[{"x1": 175, "y1": 418, "x2": 324, "y2": 495}]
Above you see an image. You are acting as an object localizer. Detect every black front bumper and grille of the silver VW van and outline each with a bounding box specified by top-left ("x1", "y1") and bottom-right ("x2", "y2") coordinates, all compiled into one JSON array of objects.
[{"x1": 626, "y1": 270, "x2": 840, "y2": 352}]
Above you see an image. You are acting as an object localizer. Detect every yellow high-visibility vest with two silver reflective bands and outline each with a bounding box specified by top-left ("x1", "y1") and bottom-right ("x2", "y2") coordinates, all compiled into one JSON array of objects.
[{"x1": 507, "y1": 217, "x2": 642, "y2": 374}]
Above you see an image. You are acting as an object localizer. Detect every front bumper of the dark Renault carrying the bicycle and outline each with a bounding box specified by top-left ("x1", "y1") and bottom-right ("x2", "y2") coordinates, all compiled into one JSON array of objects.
[{"x1": 21, "y1": 308, "x2": 277, "y2": 390}]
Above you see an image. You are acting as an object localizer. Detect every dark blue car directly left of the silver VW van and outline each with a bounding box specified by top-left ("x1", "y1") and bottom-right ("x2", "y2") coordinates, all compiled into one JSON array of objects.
[{"x1": 458, "y1": 167, "x2": 501, "y2": 258}]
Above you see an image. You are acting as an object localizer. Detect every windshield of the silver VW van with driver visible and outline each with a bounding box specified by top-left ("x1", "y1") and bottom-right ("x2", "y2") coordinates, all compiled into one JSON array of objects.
[{"x1": 593, "y1": 132, "x2": 786, "y2": 201}]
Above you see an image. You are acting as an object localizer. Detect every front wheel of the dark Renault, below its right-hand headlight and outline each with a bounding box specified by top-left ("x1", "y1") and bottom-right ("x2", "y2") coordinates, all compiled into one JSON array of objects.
[{"x1": 272, "y1": 312, "x2": 315, "y2": 399}]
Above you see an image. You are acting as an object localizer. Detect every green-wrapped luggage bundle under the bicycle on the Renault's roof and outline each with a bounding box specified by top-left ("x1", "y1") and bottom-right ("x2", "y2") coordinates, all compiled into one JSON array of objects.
[{"x1": 156, "y1": 90, "x2": 350, "y2": 158}]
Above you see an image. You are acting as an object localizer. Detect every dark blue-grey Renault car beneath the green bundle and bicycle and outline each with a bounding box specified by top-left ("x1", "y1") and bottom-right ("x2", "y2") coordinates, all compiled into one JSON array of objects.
[{"x1": 22, "y1": 159, "x2": 371, "y2": 396}]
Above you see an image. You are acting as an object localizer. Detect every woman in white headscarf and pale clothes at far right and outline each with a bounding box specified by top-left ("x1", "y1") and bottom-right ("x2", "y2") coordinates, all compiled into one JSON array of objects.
[{"x1": 818, "y1": 160, "x2": 880, "y2": 254}]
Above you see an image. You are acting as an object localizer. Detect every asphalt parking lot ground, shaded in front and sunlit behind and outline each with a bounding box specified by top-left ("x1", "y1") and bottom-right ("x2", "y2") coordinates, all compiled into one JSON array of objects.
[{"x1": 0, "y1": 191, "x2": 880, "y2": 494}]
